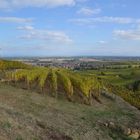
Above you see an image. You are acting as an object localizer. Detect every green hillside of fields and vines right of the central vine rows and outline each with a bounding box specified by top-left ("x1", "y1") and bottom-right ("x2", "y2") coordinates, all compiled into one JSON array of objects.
[{"x1": 79, "y1": 65, "x2": 140, "y2": 109}]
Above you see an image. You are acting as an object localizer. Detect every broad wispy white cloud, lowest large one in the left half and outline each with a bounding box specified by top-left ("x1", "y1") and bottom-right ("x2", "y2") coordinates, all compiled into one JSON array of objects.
[{"x1": 17, "y1": 26, "x2": 73, "y2": 43}]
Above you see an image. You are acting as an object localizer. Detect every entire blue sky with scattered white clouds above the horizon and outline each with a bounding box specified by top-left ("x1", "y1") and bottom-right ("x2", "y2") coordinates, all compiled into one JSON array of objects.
[{"x1": 0, "y1": 0, "x2": 140, "y2": 57}]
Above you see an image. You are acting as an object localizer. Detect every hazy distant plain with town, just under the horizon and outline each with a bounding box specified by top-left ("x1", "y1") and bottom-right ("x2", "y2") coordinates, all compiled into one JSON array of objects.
[{"x1": 3, "y1": 56, "x2": 140, "y2": 70}]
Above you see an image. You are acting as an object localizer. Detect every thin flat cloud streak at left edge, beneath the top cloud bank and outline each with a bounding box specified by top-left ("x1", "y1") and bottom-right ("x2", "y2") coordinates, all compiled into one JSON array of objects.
[{"x1": 0, "y1": 17, "x2": 32, "y2": 23}]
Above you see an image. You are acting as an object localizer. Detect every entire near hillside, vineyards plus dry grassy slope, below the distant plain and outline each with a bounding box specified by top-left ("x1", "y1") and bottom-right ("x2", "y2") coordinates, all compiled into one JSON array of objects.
[{"x1": 0, "y1": 61, "x2": 140, "y2": 140}]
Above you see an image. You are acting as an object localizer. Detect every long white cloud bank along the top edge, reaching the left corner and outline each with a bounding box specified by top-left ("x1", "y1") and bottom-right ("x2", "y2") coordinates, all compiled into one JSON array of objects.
[{"x1": 0, "y1": 0, "x2": 82, "y2": 9}]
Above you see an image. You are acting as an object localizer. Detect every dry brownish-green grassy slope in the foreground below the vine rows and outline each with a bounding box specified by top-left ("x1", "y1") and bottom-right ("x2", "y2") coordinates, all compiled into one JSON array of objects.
[{"x1": 0, "y1": 84, "x2": 140, "y2": 140}]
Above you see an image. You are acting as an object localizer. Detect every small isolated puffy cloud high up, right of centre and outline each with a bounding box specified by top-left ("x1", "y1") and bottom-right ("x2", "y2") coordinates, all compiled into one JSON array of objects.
[{"x1": 77, "y1": 7, "x2": 101, "y2": 16}]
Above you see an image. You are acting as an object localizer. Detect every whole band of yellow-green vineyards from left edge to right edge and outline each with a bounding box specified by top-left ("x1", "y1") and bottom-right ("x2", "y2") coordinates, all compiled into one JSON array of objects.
[{"x1": 0, "y1": 60, "x2": 140, "y2": 108}]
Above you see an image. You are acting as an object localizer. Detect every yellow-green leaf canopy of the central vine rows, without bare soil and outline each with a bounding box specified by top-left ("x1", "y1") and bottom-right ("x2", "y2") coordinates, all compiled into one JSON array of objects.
[{"x1": 6, "y1": 67, "x2": 102, "y2": 103}]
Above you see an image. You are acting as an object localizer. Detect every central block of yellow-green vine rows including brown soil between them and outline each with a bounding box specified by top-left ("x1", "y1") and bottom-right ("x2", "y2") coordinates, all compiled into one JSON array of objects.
[{"x1": 6, "y1": 67, "x2": 102, "y2": 104}]
